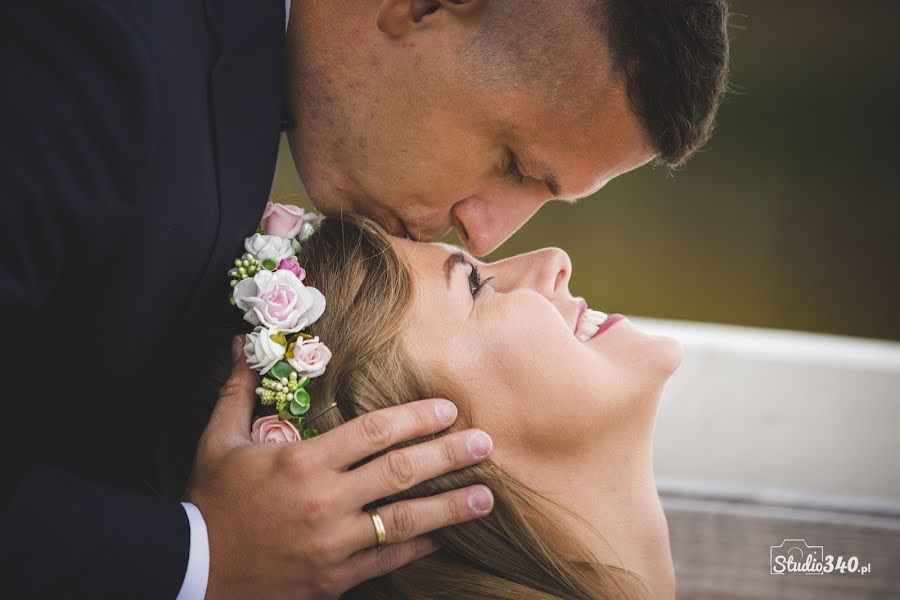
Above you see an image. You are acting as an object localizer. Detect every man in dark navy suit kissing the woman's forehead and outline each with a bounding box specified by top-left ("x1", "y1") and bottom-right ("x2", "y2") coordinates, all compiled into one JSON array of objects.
[{"x1": 0, "y1": 0, "x2": 728, "y2": 598}]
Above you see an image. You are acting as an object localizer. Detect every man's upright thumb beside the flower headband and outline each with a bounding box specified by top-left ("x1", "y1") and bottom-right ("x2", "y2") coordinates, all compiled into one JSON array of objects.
[{"x1": 206, "y1": 335, "x2": 258, "y2": 447}]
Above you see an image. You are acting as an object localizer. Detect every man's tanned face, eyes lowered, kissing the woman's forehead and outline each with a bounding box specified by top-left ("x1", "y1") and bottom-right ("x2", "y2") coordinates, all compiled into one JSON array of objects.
[{"x1": 288, "y1": 0, "x2": 654, "y2": 256}]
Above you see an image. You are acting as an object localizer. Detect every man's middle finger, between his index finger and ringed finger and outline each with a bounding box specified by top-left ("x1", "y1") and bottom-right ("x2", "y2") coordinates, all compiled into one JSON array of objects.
[{"x1": 338, "y1": 429, "x2": 493, "y2": 507}]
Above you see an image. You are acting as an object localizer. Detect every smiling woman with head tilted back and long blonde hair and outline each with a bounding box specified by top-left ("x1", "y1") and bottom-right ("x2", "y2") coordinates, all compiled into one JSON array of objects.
[{"x1": 230, "y1": 217, "x2": 681, "y2": 600}]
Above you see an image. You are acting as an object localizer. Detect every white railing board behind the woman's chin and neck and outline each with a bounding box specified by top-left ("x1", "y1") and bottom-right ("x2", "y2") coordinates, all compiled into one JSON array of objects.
[{"x1": 633, "y1": 318, "x2": 900, "y2": 508}]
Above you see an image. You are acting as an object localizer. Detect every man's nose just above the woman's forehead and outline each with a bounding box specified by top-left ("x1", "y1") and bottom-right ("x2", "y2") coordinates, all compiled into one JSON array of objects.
[{"x1": 450, "y1": 193, "x2": 549, "y2": 256}]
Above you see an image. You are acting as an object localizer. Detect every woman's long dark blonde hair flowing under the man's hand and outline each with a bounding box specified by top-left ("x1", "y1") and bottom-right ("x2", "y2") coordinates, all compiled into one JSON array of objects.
[{"x1": 300, "y1": 216, "x2": 646, "y2": 600}]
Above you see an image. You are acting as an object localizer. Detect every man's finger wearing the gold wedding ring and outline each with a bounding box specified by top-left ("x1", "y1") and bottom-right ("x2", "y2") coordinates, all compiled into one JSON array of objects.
[{"x1": 348, "y1": 485, "x2": 494, "y2": 549}]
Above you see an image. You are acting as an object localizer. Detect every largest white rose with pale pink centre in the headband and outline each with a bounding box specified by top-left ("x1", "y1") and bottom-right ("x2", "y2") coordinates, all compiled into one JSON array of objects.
[{"x1": 234, "y1": 270, "x2": 325, "y2": 333}]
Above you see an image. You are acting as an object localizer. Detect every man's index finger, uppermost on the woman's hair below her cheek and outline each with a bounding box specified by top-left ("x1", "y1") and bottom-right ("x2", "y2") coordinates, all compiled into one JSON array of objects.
[{"x1": 312, "y1": 400, "x2": 457, "y2": 468}]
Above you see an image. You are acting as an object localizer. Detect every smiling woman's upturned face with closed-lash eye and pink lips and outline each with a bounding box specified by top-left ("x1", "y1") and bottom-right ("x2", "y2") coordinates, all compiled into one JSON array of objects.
[{"x1": 392, "y1": 239, "x2": 681, "y2": 458}]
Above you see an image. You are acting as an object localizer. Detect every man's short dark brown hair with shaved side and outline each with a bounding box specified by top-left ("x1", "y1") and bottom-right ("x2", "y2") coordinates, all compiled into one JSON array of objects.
[{"x1": 473, "y1": 0, "x2": 729, "y2": 167}]
